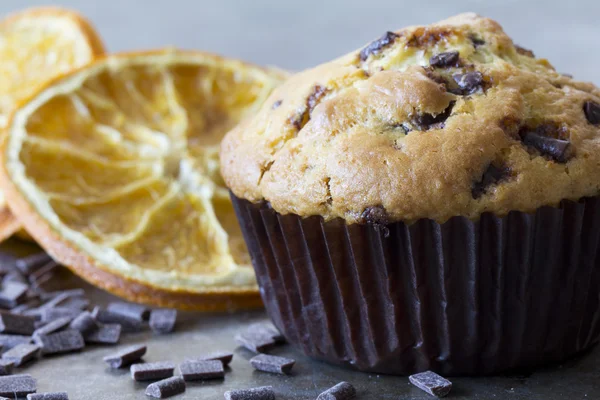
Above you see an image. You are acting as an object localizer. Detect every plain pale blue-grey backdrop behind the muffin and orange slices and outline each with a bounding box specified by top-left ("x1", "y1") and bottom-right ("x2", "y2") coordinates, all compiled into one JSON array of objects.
[{"x1": 0, "y1": 0, "x2": 600, "y2": 84}]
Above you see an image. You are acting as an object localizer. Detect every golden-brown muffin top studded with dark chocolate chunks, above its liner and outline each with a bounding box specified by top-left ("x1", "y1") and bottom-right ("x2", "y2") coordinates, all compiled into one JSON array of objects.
[{"x1": 221, "y1": 14, "x2": 600, "y2": 223}]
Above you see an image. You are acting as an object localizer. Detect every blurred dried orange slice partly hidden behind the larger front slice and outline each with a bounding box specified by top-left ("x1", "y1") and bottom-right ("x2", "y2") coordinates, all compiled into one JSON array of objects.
[{"x1": 0, "y1": 7, "x2": 104, "y2": 241}]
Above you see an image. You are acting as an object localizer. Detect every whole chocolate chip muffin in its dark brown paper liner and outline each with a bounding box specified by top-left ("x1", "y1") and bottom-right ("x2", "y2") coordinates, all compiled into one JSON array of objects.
[{"x1": 221, "y1": 14, "x2": 600, "y2": 375}]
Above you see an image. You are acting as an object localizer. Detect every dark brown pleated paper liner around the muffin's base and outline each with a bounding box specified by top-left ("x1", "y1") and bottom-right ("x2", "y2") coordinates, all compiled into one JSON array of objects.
[{"x1": 232, "y1": 196, "x2": 600, "y2": 375}]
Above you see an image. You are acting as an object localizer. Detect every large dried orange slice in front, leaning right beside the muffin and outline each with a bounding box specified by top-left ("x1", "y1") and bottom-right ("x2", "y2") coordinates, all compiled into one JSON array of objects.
[{"x1": 2, "y1": 50, "x2": 286, "y2": 310}]
